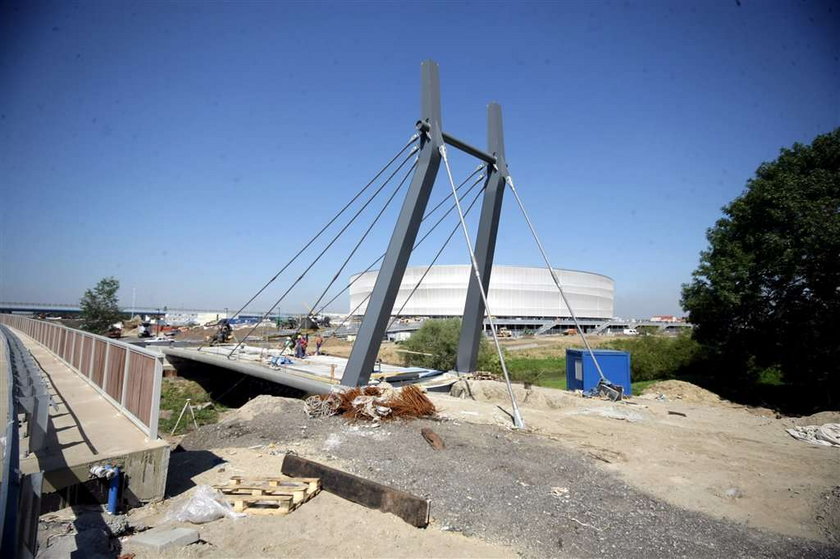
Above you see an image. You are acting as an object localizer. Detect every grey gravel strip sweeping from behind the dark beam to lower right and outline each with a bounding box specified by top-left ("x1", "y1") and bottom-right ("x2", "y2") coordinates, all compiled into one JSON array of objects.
[{"x1": 180, "y1": 398, "x2": 840, "y2": 558}]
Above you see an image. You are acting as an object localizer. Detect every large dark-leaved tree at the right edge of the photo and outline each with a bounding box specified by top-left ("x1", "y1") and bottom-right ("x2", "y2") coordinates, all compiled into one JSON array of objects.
[{"x1": 682, "y1": 128, "x2": 840, "y2": 403}]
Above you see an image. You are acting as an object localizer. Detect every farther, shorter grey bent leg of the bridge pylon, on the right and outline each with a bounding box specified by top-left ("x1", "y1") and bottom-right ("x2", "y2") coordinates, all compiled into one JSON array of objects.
[{"x1": 455, "y1": 103, "x2": 508, "y2": 373}]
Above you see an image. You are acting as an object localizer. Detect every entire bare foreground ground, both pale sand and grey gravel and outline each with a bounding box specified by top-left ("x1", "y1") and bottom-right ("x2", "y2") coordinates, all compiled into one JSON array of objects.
[{"x1": 101, "y1": 381, "x2": 840, "y2": 559}]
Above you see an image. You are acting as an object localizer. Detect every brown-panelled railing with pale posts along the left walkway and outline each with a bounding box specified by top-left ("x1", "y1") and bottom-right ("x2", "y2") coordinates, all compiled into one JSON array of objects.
[{"x1": 0, "y1": 314, "x2": 163, "y2": 439}]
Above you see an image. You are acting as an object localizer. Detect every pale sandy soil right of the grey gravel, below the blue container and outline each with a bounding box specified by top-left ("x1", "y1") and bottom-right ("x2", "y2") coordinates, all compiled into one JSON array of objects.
[{"x1": 436, "y1": 381, "x2": 840, "y2": 541}]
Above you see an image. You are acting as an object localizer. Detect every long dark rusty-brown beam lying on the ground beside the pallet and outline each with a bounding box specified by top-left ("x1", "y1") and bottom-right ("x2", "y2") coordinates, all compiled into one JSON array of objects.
[{"x1": 281, "y1": 454, "x2": 431, "y2": 528}]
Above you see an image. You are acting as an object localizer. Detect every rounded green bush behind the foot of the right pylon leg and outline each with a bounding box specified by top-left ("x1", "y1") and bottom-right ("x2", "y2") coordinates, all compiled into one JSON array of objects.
[{"x1": 403, "y1": 318, "x2": 501, "y2": 373}]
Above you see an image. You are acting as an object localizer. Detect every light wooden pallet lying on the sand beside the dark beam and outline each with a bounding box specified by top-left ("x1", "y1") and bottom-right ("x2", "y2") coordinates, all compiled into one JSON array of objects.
[{"x1": 214, "y1": 476, "x2": 321, "y2": 515}]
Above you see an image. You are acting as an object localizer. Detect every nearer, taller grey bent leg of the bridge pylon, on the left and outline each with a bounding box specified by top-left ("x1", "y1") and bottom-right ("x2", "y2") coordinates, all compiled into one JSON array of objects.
[{"x1": 341, "y1": 60, "x2": 443, "y2": 386}]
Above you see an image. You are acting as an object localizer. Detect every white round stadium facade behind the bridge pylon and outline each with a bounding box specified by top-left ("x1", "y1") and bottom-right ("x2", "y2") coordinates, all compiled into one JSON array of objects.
[{"x1": 350, "y1": 265, "x2": 615, "y2": 329}]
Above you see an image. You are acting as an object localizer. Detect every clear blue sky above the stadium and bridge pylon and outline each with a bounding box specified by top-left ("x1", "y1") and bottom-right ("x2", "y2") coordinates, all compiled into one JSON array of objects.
[{"x1": 0, "y1": 0, "x2": 840, "y2": 317}]
